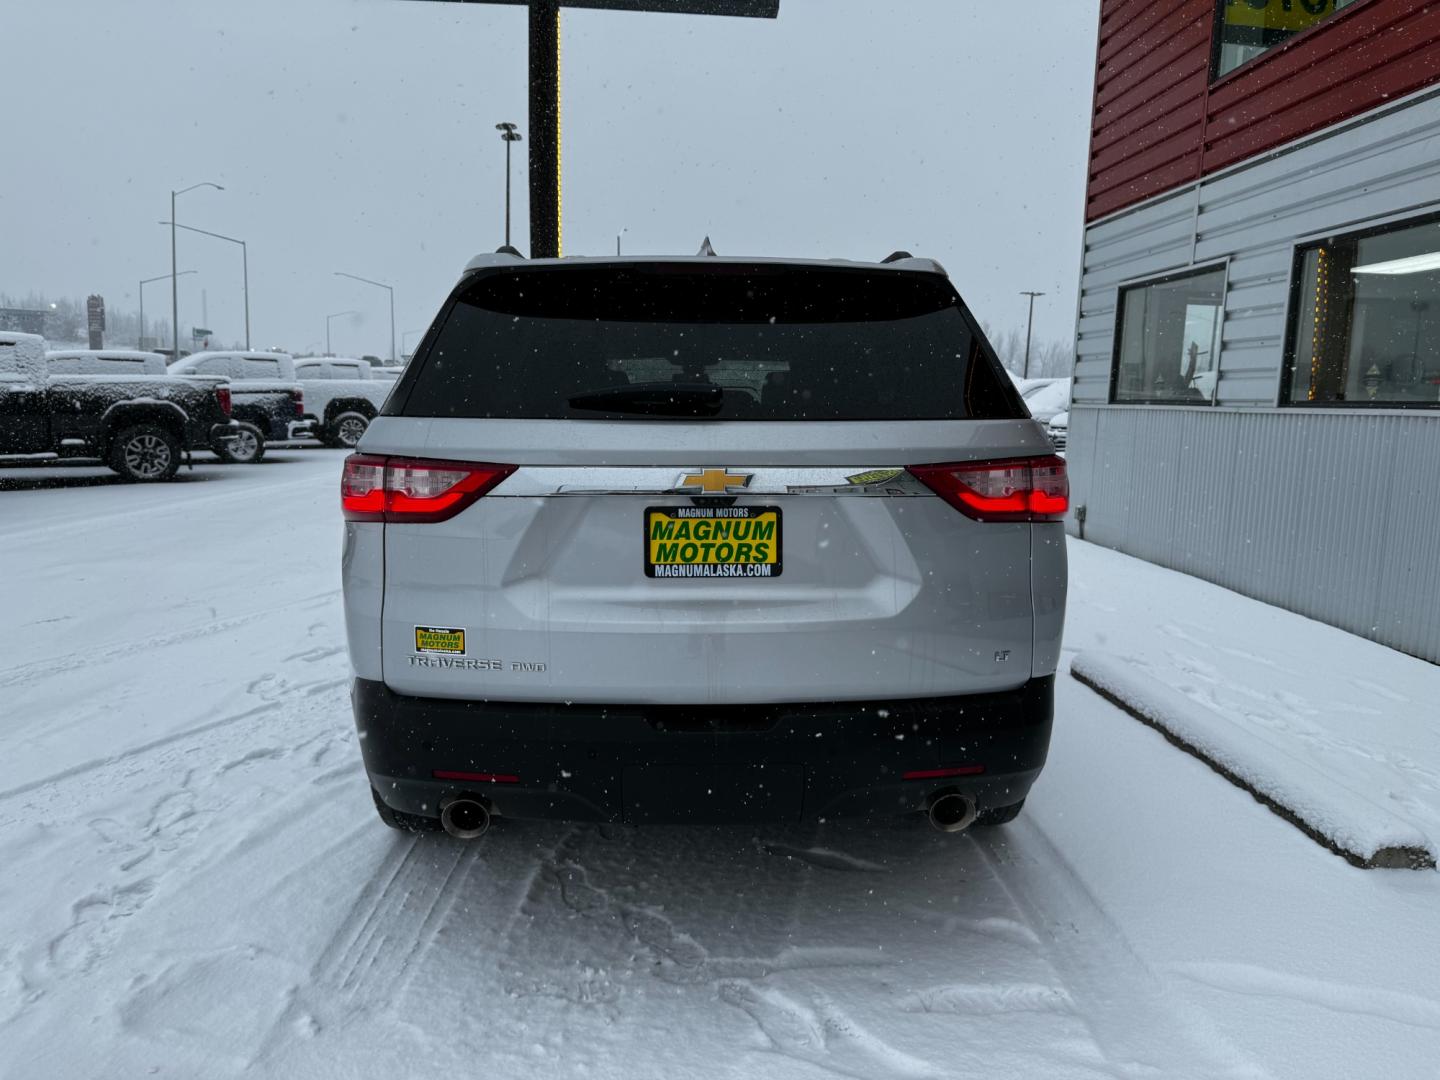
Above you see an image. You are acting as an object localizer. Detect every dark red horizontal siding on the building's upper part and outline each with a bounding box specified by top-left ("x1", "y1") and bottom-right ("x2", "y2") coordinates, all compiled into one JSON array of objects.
[{"x1": 1086, "y1": 0, "x2": 1440, "y2": 220}]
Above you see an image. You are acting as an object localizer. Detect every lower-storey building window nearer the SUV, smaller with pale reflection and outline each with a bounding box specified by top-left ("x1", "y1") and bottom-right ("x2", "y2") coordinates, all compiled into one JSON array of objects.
[{"x1": 1112, "y1": 266, "x2": 1225, "y2": 405}]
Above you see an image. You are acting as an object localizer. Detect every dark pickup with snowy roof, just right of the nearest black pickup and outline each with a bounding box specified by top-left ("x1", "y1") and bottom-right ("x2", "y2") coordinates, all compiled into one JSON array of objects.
[{"x1": 170, "y1": 353, "x2": 314, "y2": 462}]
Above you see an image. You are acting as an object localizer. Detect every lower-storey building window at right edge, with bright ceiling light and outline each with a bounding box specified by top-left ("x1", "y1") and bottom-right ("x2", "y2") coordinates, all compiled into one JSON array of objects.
[{"x1": 1287, "y1": 219, "x2": 1440, "y2": 406}]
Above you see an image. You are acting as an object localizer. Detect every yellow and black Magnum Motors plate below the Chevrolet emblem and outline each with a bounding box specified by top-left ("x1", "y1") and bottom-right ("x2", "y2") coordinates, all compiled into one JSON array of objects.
[{"x1": 645, "y1": 507, "x2": 780, "y2": 577}]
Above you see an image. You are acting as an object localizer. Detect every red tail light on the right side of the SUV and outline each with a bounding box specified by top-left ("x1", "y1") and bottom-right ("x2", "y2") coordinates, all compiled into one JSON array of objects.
[{"x1": 907, "y1": 456, "x2": 1070, "y2": 521}]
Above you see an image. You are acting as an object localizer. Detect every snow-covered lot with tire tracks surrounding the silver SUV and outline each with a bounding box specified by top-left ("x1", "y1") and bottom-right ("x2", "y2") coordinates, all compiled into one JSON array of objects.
[{"x1": 0, "y1": 451, "x2": 1440, "y2": 1080}]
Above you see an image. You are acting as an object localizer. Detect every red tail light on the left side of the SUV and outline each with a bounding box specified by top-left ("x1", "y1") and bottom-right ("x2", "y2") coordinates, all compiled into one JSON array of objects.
[{"x1": 340, "y1": 454, "x2": 516, "y2": 524}]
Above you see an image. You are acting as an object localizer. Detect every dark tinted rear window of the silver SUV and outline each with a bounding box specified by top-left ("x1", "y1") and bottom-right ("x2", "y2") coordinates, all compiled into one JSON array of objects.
[{"x1": 386, "y1": 264, "x2": 1025, "y2": 420}]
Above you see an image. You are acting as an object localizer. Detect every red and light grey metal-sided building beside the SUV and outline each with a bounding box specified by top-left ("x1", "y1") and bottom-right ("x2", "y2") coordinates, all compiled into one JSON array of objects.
[{"x1": 1068, "y1": 0, "x2": 1440, "y2": 662}]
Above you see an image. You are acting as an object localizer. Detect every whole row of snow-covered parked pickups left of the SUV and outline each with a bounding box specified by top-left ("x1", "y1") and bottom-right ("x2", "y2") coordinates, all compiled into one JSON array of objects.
[{"x1": 0, "y1": 333, "x2": 406, "y2": 481}]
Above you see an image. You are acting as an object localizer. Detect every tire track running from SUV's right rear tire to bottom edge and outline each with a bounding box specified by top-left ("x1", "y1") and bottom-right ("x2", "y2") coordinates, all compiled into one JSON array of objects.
[{"x1": 971, "y1": 818, "x2": 1270, "y2": 1080}]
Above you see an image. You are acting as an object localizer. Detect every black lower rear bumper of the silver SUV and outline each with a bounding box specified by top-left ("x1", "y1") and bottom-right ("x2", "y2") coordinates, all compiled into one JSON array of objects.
[{"x1": 351, "y1": 675, "x2": 1054, "y2": 824}]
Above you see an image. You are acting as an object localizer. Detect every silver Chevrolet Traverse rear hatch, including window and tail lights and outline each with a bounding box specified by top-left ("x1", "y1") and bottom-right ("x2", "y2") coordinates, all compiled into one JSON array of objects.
[{"x1": 357, "y1": 261, "x2": 1063, "y2": 704}]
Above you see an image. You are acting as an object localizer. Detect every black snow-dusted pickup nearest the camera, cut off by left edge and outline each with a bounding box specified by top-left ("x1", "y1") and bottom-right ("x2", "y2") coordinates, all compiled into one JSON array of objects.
[{"x1": 0, "y1": 333, "x2": 235, "y2": 481}]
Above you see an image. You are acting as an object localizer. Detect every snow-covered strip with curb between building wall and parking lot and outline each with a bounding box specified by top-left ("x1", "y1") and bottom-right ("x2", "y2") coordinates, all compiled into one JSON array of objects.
[{"x1": 1070, "y1": 541, "x2": 1440, "y2": 867}]
